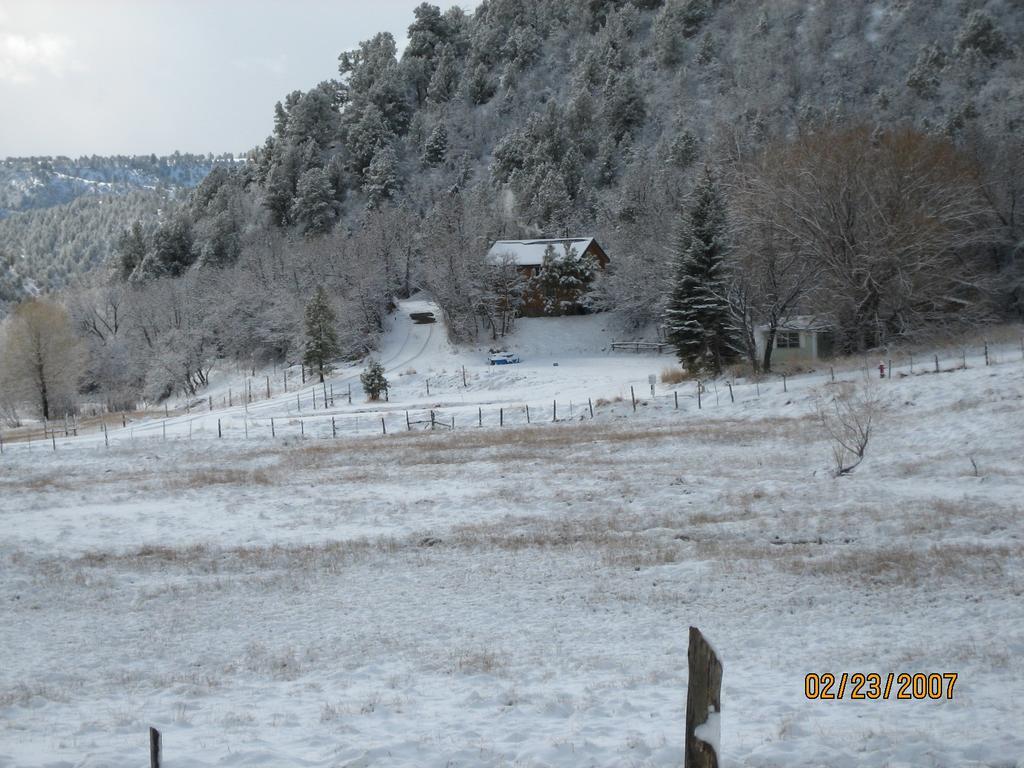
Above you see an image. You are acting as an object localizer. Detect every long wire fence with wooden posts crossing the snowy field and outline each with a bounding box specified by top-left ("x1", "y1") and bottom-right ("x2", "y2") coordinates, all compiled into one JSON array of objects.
[{"x1": 0, "y1": 337, "x2": 1024, "y2": 456}]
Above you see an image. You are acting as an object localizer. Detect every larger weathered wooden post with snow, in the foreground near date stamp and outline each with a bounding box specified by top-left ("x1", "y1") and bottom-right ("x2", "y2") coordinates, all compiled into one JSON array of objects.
[{"x1": 683, "y1": 627, "x2": 722, "y2": 768}]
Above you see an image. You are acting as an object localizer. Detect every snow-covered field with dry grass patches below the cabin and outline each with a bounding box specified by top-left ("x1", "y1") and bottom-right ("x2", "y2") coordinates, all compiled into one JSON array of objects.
[{"x1": 0, "y1": 306, "x2": 1024, "y2": 768}]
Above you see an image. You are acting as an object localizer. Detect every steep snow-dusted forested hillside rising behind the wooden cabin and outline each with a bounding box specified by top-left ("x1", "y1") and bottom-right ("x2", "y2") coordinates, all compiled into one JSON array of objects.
[{"x1": 2, "y1": 0, "x2": 1024, "y2": 415}]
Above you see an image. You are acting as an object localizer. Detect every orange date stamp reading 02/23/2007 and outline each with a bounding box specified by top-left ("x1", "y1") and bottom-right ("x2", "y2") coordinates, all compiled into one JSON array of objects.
[{"x1": 804, "y1": 672, "x2": 957, "y2": 701}]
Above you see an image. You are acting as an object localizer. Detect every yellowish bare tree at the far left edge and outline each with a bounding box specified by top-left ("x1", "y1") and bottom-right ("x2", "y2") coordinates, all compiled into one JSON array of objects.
[{"x1": 2, "y1": 299, "x2": 85, "y2": 419}]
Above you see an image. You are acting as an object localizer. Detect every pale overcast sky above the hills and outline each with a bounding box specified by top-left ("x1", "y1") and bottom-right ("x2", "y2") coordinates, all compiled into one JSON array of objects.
[{"x1": 0, "y1": 0, "x2": 474, "y2": 157}]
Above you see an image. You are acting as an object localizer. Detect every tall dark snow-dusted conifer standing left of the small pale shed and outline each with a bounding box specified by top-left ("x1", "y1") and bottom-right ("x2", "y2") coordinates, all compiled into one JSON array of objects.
[{"x1": 665, "y1": 168, "x2": 738, "y2": 376}]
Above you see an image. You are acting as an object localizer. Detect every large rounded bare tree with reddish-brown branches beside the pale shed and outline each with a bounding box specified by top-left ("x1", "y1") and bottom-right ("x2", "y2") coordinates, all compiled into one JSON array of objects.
[{"x1": 764, "y1": 127, "x2": 990, "y2": 350}]
